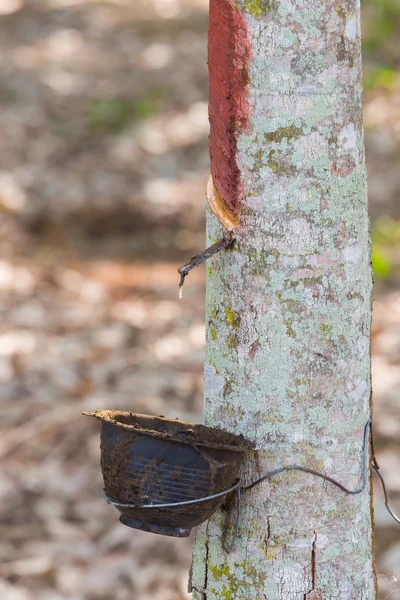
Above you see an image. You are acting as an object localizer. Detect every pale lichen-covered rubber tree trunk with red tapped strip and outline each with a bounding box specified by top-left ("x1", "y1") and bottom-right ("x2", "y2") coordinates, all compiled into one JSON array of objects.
[{"x1": 192, "y1": 0, "x2": 376, "y2": 600}]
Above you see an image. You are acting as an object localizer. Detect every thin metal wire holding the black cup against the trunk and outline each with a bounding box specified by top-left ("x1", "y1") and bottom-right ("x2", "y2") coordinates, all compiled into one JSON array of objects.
[{"x1": 105, "y1": 420, "x2": 400, "y2": 554}]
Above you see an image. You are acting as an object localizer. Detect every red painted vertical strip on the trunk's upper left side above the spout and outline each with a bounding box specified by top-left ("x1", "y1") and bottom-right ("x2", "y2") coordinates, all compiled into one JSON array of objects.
[{"x1": 208, "y1": 0, "x2": 250, "y2": 224}]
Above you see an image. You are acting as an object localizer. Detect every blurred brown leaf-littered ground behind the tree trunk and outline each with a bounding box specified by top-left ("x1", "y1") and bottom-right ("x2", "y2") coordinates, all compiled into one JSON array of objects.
[{"x1": 0, "y1": 0, "x2": 400, "y2": 600}]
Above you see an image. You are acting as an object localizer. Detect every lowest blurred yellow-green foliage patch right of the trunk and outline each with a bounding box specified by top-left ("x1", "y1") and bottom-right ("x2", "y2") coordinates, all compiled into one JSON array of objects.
[{"x1": 371, "y1": 215, "x2": 400, "y2": 279}]
